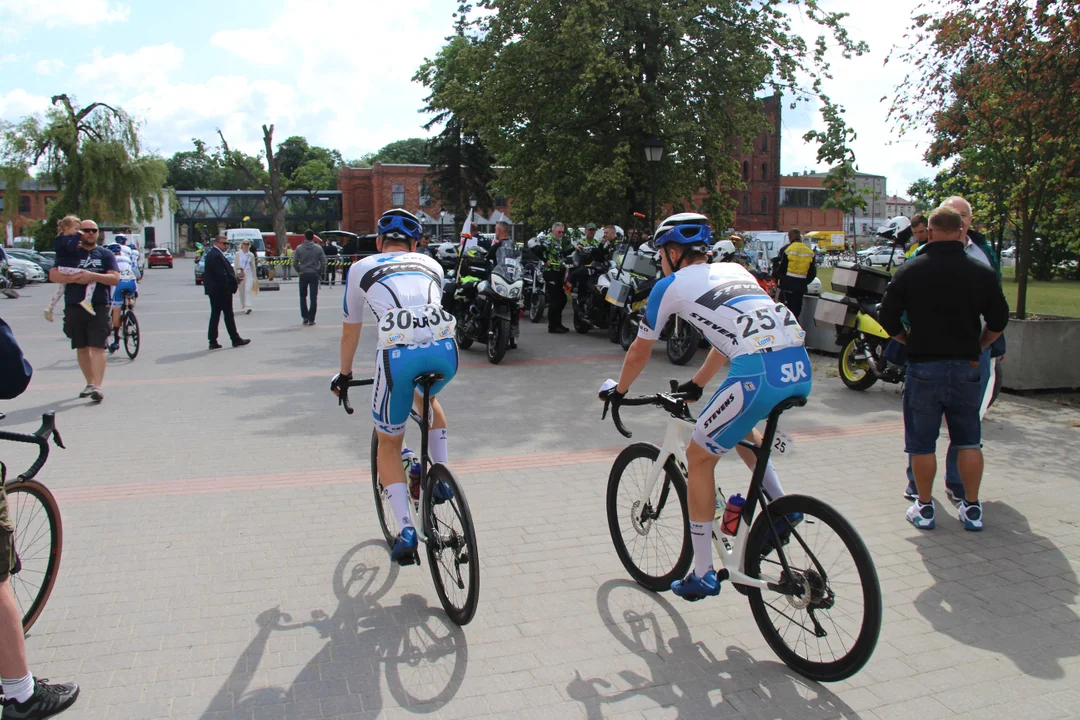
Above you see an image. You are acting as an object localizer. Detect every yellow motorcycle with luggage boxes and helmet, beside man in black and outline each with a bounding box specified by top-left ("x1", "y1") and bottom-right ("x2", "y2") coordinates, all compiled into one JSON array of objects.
[{"x1": 814, "y1": 217, "x2": 912, "y2": 390}]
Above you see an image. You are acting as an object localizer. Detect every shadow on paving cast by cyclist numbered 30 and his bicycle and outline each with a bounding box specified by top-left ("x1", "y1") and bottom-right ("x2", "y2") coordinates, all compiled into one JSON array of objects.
[{"x1": 203, "y1": 540, "x2": 469, "y2": 720}]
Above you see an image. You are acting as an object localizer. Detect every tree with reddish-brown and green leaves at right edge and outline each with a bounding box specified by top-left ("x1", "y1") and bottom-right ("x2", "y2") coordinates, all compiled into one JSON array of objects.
[{"x1": 890, "y1": 0, "x2": 1080, "y2": 318}]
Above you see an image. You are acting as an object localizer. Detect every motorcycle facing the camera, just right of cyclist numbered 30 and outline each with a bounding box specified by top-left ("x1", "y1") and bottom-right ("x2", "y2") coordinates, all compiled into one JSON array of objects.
[{"x1": 444, "y1": 241, "x2": 525, "y2": 365}]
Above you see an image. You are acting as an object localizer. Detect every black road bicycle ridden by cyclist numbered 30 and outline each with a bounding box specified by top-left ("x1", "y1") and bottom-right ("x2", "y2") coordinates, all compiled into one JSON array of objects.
[{"x1": 338, "y1": 372, "x2": 480, "y2": 625}]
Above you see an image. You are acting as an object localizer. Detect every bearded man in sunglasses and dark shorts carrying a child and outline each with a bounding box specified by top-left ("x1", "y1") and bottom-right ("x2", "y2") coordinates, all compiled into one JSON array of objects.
[{"x1": 49, "y1": 220, "x2": 120, "y2": 403}]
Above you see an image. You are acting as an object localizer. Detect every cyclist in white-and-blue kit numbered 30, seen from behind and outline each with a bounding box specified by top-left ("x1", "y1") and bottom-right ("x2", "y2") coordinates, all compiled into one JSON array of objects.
[{"x1": 330, "y1": 209, "x2": 458, "y2": 565}]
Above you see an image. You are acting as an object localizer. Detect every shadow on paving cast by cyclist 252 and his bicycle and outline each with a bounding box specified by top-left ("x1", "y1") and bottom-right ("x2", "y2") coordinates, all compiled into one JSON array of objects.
[{"x1": 566, "y1": 580, "x2": 859, "y2": 720}]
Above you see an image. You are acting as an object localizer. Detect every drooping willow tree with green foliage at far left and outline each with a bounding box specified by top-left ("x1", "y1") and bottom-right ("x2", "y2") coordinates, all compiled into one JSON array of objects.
[{"x1": 0, "y1": 95, "x2": 167, "y2": 247}]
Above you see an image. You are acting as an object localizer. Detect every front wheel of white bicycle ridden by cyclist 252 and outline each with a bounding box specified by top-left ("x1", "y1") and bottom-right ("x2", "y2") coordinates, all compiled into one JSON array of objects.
[{"x1": 607, "y1": 443, "x2": 693, "y2": 593}]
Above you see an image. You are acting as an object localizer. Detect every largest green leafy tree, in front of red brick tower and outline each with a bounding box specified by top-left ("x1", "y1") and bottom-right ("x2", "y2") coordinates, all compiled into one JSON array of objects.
[{"x1": 421, "y1": 0, "x2": 866, "y2": 227}]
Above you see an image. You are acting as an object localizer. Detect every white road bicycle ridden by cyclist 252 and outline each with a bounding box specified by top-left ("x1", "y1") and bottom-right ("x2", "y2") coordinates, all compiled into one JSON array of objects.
[{"x1": 603, "y1": 381, "x2": 881, "y2": 682}]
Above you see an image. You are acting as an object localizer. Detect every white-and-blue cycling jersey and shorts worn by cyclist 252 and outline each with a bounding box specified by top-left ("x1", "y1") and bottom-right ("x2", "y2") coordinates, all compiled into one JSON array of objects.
[{"x1": 638, "y1": 262, "x2": 811, "y2": 456}]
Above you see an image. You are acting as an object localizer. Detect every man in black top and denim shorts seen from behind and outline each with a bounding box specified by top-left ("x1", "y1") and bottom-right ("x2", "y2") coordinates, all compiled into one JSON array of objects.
[{"x1": 879, "y1": 206, "x2": 1009, "y2": 530}]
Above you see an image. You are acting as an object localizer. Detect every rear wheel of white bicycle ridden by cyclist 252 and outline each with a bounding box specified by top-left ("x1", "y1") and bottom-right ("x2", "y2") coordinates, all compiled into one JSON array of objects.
[{"x1": 746, "y1": 495, "x2": 881, "y2": 682}]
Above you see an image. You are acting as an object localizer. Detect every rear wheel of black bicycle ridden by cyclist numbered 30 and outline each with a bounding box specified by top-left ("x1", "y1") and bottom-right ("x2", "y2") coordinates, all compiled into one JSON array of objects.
[{"x1": 423, "y1": 463, "x2": 480, "y2": 625}]
